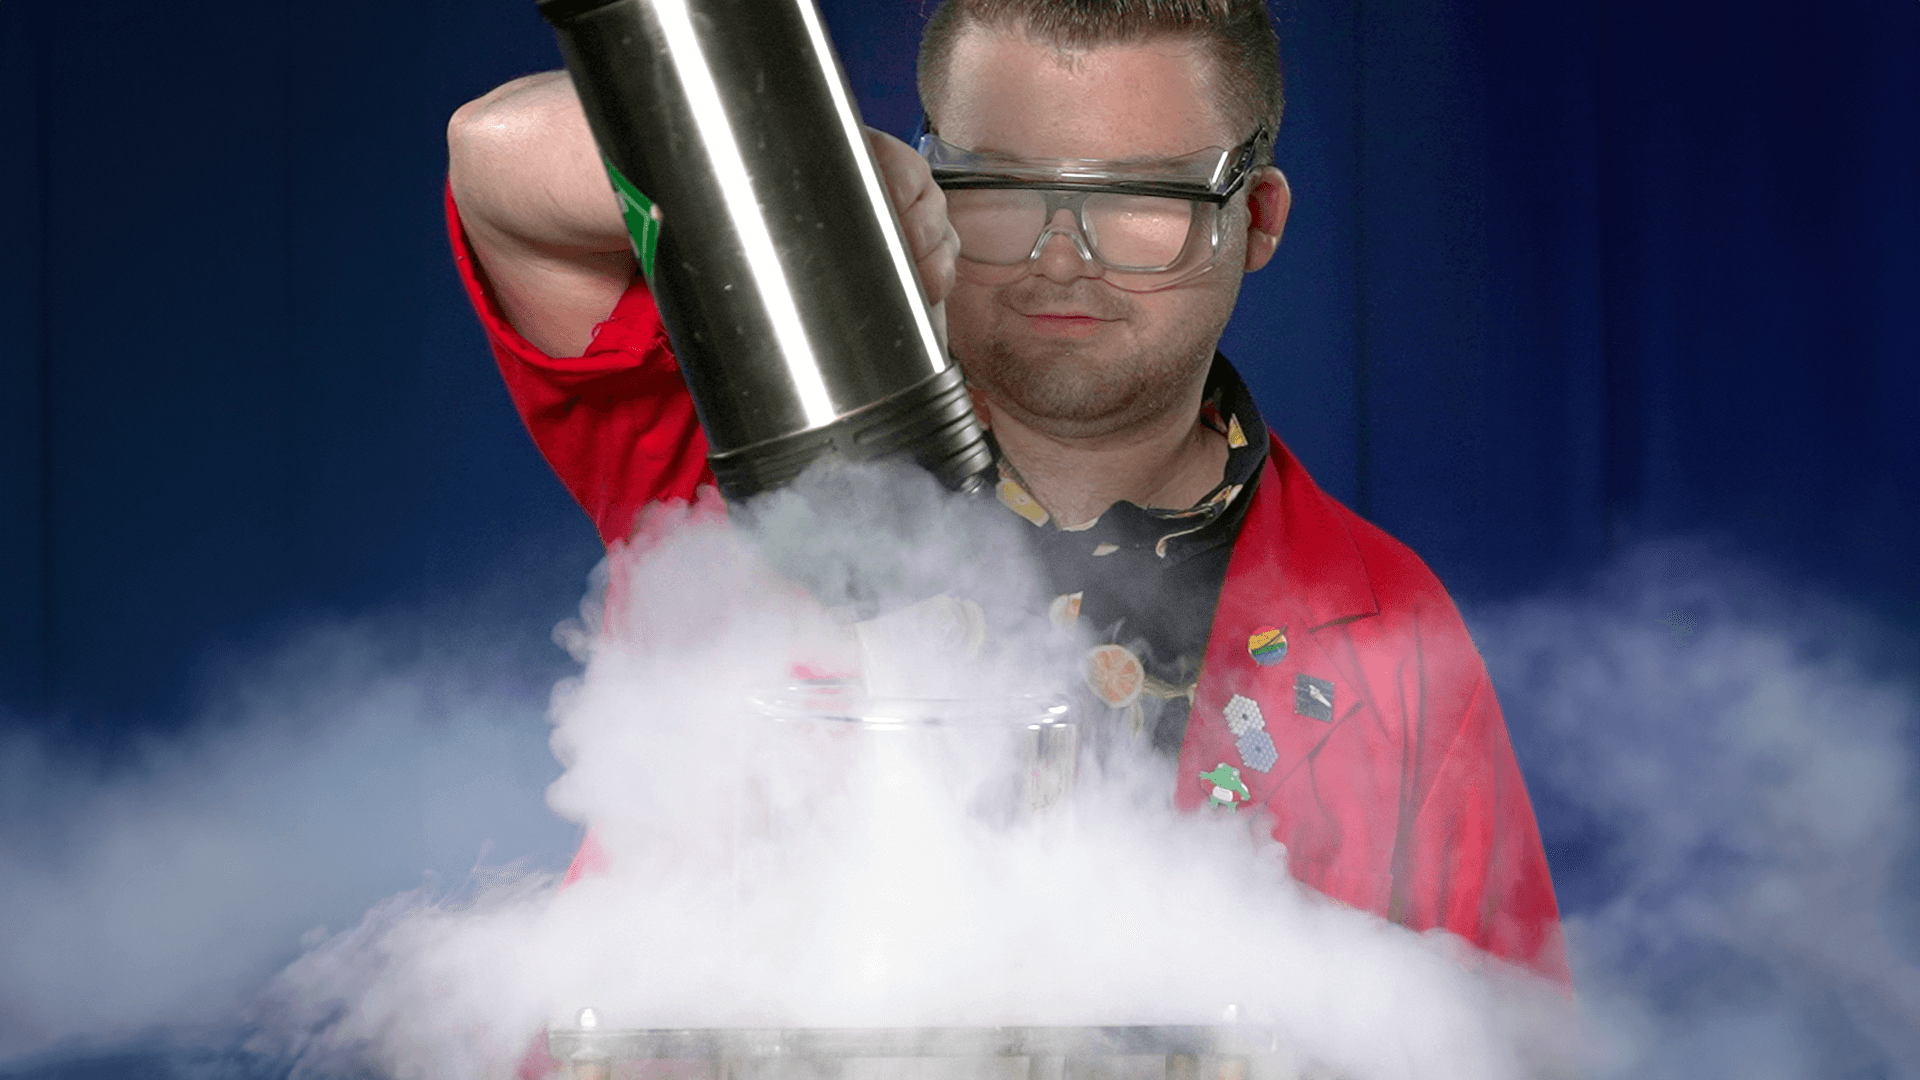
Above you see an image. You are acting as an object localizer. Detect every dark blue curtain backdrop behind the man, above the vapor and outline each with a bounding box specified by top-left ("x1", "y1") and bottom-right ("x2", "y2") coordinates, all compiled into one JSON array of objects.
[{"x1": 0, "y1": 0, "x2": 1920, "y2": 732}]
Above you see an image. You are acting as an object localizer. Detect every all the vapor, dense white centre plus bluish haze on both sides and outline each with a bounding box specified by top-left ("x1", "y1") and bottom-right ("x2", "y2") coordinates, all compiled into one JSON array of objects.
[{"x1": 0, "y1": 486, "x2": 1920, "y2": 1080}]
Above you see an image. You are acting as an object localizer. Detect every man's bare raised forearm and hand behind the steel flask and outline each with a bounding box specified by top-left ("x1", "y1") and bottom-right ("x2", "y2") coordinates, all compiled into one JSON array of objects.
[{"x1": 447, "y1": 71, "x2": 960, "y2": 357}]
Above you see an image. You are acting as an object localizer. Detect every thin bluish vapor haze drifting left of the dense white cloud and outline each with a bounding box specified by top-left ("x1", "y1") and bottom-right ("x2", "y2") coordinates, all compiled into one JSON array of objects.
[{"x1": 0, "y1": 621, "x2": 574, "y2": 1068}]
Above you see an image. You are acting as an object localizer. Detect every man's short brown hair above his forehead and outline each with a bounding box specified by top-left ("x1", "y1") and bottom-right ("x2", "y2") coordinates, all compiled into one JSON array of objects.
[{"x1": 920, "y1": 0, "x2": 1286, "y2": 147}]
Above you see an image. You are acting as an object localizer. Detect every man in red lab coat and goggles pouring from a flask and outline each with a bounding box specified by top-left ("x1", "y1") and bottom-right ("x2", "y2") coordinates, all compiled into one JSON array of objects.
[{"x1": 449, "y1": 0, "x2": 1567, "y2": 980}]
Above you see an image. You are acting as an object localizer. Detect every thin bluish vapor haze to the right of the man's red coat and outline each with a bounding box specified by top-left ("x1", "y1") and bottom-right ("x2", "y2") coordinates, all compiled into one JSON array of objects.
[{"x1": 1475, "y1": 542, "x2": 1920, "y2": 1078}]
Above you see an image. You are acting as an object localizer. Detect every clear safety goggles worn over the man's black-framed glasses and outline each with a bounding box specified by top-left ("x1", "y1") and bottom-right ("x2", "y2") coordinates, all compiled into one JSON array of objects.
[{"x1": 918, "y1": 121, "x2": 1267, "y2": 292}]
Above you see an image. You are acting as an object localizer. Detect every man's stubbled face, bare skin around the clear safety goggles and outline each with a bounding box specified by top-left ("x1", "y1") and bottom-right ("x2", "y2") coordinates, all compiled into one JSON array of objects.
[{"x1": 931, "y1": 27, "x2": 1284, "y2": 438}]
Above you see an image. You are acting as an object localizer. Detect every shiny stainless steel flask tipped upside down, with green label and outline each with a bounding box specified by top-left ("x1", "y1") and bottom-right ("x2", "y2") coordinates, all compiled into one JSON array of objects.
[{"x1": 540, "y1": 0, "x2": 991, "y2": 500}]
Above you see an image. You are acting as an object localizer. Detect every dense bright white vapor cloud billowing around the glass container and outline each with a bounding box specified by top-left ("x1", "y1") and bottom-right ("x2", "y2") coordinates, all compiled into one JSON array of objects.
[{"x1": 255, "y1": 475, "x2": 1571, "y2": 1080}]
